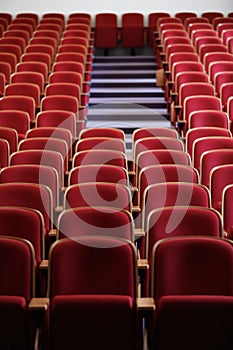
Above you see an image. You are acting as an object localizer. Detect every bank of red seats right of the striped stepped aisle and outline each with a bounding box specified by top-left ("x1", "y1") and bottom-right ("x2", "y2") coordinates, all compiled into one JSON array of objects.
[{"x1": 153, "y1": 18, "x2": 232, "y2": 227}]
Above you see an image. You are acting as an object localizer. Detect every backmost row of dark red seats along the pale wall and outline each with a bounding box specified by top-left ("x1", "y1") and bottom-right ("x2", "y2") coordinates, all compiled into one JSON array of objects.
[{"x1": 0, "y1": 11, "x2": 231, "y2": 48}]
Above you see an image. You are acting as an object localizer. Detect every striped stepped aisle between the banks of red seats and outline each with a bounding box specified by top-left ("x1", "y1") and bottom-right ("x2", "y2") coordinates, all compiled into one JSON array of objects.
[{"x1": 87, "y1": 55, "x2": 170, "y2": 157}]
